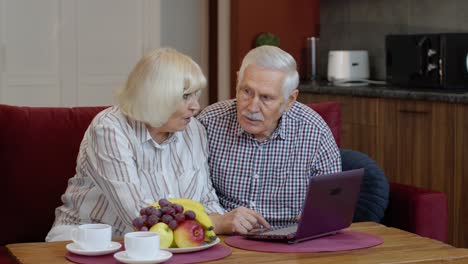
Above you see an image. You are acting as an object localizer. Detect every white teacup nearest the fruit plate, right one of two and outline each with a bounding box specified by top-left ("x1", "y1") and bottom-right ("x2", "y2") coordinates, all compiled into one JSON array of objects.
[{"x1": 124, "y1": 231, "x2": 160, "y2": 259}]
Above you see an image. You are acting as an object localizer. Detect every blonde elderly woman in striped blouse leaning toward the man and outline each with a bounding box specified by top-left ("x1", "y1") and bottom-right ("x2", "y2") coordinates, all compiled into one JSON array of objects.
[{"x1": 46, "y1": 48, "x2": 229, "y2": 241}]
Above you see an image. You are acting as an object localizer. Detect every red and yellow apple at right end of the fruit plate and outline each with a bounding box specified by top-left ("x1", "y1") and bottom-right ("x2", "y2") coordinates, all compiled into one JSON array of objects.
[{"x1": 174, "y1": 220, "x2": 205, "y2": 248}]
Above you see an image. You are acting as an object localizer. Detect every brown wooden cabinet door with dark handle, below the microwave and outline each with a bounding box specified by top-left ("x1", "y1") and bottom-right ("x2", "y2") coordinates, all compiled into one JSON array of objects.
[{"x1": 378, "y1": 99, "x2": 458, "y2": 243}]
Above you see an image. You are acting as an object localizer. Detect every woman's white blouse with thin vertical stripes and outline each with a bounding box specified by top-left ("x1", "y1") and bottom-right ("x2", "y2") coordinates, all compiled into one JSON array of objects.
[{"x1": 48, "y1": 106, "x2": 224, "y2": 236}]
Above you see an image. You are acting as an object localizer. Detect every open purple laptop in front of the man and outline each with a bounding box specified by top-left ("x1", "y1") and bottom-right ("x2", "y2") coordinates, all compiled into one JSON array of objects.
[{"x1": 243, "y1": 169, "x2": 364, "y2": 243}]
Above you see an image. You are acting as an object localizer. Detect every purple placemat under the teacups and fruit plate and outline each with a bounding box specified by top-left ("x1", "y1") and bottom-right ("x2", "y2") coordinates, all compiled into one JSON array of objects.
[{"x1": 65, "y1": 244, "x2": 232, "y2": 264}]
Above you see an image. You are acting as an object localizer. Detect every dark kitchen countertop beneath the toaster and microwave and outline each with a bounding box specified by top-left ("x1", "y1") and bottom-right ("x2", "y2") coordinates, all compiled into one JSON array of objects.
[{"x1": 299, "y1": 81, "x2": 468, "y2": 104}]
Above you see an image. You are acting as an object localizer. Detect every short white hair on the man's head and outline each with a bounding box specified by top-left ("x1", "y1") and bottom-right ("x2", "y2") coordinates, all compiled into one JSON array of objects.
[{"x1": 237, "y1": 45, "x2": 299, "y2": 99}]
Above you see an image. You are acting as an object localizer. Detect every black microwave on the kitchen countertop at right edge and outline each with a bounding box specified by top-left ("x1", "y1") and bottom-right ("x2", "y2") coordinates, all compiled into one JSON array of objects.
[{"x1": 385, "y1": 33, "x2": 468, "y2": 90}]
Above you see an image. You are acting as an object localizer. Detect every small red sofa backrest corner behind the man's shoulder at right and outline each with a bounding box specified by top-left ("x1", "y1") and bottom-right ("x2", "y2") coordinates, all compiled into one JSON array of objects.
[{"x1": 307, "y1": 102, "x2": 341, "y2": 147}]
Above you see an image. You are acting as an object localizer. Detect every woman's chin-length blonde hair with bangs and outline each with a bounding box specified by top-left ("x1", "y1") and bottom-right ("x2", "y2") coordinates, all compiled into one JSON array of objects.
[{"x1": 116, "y1": 48, "x2": 206, "y2": 127}]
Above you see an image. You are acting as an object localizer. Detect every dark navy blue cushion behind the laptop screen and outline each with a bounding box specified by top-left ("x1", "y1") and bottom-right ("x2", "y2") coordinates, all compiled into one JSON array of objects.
[{"x1": 340, "y1": 149, "x2": 389, "y2": 222}]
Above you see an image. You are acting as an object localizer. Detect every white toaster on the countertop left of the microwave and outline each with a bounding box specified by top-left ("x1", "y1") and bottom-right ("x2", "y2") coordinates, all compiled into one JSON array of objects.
[{"x1": 327, "y1": 50, "x2": 369, "y2": 86}]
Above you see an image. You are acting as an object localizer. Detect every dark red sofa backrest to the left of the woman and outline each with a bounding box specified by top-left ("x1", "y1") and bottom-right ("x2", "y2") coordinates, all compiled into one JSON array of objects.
[{"x1": 0, "y1": 105, "x2": 104, "y2": 245}]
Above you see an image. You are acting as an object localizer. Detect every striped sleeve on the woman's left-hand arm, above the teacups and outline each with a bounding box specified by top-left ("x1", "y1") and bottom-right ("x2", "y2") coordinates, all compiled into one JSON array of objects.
[{"x1": 86, "y1": 120, "x2": 148, "y2": 226}]
